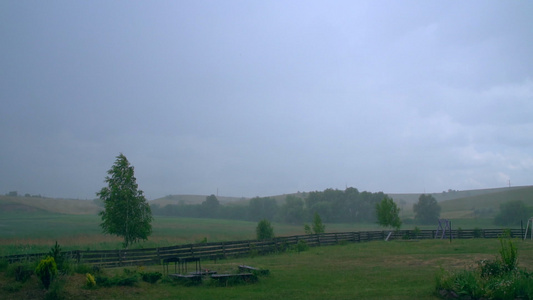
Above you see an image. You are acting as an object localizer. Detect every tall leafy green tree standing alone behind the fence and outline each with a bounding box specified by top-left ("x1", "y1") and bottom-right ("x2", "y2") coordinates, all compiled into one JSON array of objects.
[{"x1": 97, "y1": 153, "x2": 153, "y2": 248}]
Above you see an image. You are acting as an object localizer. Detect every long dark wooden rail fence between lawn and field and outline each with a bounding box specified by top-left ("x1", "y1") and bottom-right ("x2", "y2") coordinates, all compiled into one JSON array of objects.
[{"x1": 3, "y1": 228, "x2": 524, "y2": 268}]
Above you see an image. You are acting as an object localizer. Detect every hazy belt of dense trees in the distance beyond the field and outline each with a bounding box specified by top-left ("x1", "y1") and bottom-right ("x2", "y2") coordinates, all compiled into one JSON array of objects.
[{"x1": 151, "y1": 187, "x2": 386, "y2": 224}]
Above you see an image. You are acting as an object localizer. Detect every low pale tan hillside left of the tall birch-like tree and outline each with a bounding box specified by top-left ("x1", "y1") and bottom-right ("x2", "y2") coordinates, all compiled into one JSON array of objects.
[{"x1": 0, "y1": 196, "x2": 101, "y2": 215}]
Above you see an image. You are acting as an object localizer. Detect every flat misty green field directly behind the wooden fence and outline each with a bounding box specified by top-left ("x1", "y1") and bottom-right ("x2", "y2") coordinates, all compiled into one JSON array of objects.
[{"x1": 0, "y1": 212, "x2": 368, "y2": 256}]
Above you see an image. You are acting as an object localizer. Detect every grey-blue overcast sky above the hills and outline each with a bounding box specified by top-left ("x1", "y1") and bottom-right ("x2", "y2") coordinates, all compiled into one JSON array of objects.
[{"x1": 0, "y1": 0, "x2": 533, "y2": 199}]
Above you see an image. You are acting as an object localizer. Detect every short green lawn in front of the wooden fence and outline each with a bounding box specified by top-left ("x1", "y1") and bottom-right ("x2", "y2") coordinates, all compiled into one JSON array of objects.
[{"x1": 0, "y1": 239, "x2": 533, "y2": 299}]
